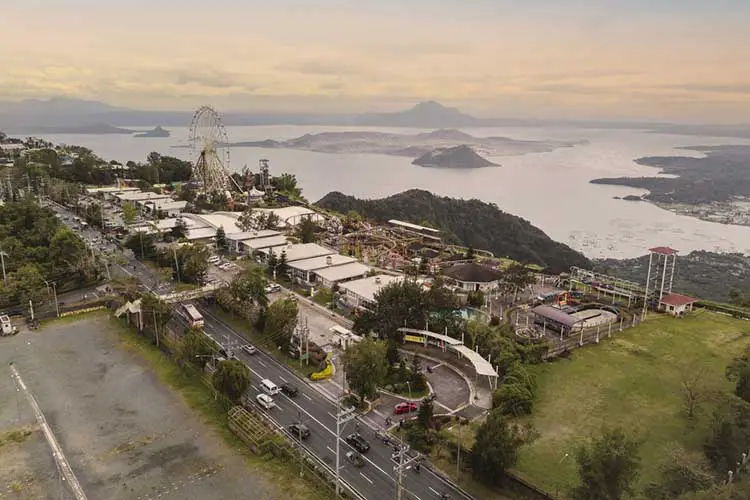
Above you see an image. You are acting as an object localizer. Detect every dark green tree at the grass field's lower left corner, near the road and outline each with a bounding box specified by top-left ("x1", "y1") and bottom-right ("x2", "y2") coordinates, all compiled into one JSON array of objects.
[{"x1": 471, "y1": 410, "x2": 531, "y2": 485}]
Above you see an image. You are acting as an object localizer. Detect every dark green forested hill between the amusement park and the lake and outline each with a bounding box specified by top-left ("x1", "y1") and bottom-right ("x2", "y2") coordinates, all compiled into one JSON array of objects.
[{"x1": 316, "y1": 189, "x2": 591, "y2": 272}]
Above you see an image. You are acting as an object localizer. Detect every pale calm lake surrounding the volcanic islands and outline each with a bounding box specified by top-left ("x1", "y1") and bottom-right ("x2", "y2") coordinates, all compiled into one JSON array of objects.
[{"x1": 35, "y1": 126, "x2": 750, "y2": 258}]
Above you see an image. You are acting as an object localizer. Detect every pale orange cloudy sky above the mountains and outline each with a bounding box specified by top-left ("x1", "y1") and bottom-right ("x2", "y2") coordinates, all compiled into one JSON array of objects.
[{"x1": 0, "y1": 0, "x2": 750, "y2": 123}]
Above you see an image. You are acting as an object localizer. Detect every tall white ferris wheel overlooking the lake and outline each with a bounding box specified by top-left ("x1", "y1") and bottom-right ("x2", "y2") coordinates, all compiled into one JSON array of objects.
[{"x1": 189, "y1": 106, "x2": 229, "y2": 194}]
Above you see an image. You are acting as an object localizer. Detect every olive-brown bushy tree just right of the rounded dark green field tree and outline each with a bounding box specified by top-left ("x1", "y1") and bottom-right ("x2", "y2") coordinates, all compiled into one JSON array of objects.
[{"x1": 644, "y1": 445, "x2": 714, "y2": 500}]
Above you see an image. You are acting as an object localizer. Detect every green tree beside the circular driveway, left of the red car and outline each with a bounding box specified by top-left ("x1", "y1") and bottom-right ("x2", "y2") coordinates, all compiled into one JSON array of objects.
[{"x1": 343, "y1": 338, "x2": 388, "y2": 401}]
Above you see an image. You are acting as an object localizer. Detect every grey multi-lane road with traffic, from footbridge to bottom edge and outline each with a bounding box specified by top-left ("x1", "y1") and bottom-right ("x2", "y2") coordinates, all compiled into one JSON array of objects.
[{"x1": 198, "y1": 305, "x2": 468, "y2": 500}]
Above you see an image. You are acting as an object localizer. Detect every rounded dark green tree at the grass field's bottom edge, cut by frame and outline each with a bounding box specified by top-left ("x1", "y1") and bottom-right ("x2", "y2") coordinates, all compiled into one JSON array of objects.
[{"x1": 572, "y1": 427, "x2": 640, "y2": 500}]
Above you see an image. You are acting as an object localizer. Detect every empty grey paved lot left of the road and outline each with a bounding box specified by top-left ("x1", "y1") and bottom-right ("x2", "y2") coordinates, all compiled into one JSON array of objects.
[{"x1": 0, "y1": 315, "x2": 284, "y2": 500}]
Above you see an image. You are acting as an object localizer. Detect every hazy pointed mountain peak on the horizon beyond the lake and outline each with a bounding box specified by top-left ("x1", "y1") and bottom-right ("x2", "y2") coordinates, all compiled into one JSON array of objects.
[{"x1": 355, "y1": 101, "x2": 485, "y2": 128}]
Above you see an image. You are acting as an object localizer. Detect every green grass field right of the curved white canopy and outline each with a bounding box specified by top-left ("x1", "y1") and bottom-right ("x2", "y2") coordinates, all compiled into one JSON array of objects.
[{"x1": 517, "y1": 310, "x2": 750, "y2": 496}]
